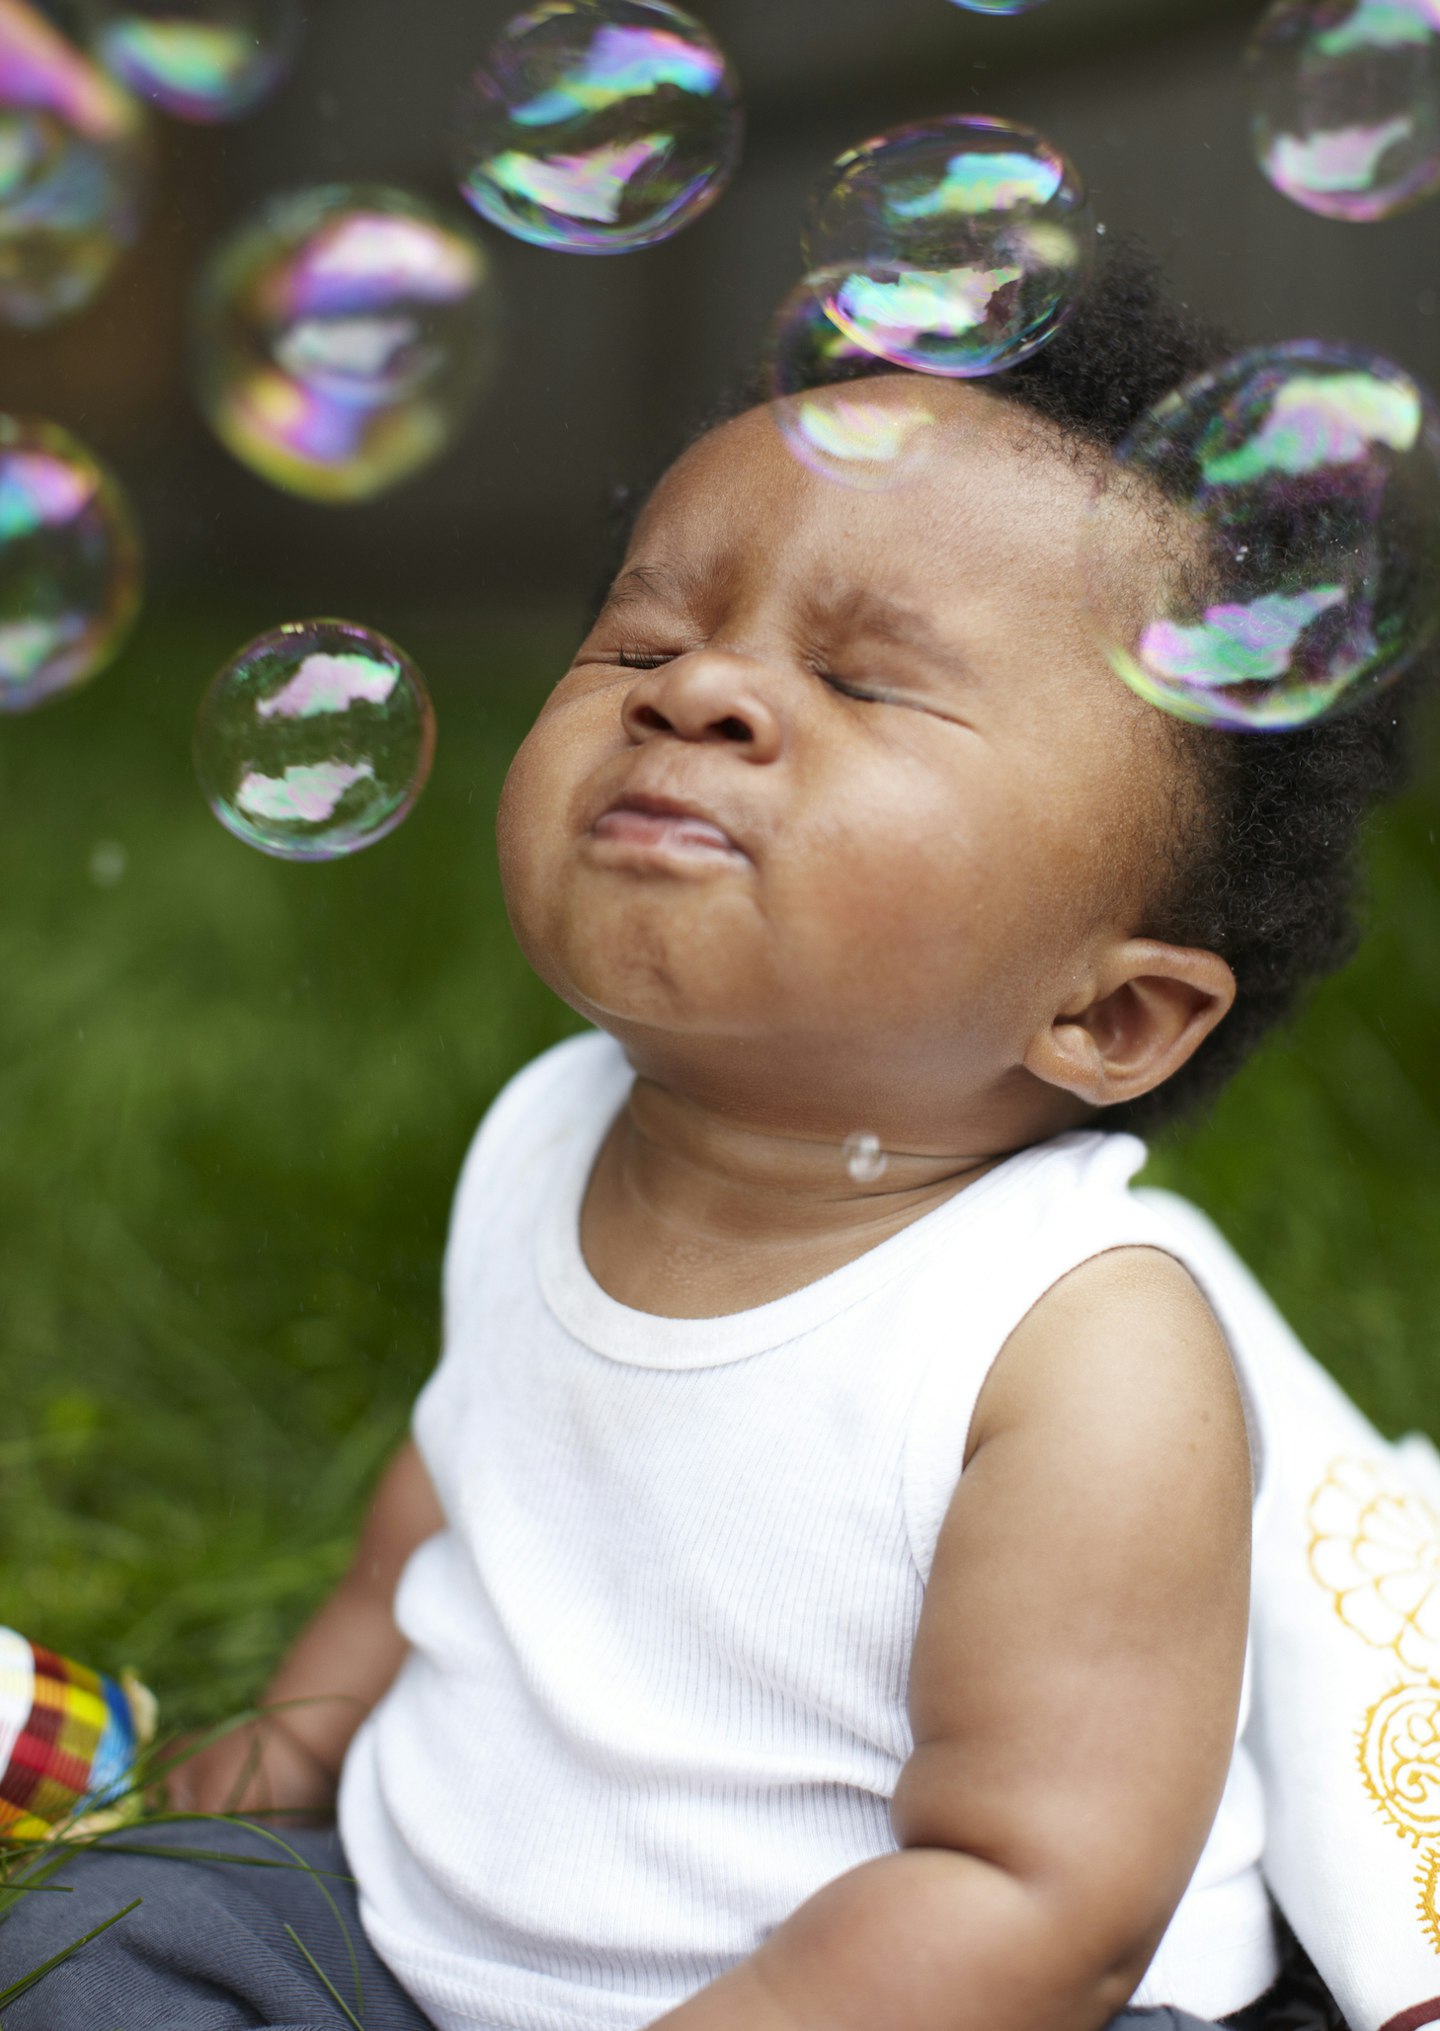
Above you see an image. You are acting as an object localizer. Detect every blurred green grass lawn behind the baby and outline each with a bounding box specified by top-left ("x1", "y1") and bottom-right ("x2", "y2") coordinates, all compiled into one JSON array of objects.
[{"x1": 0, "y1": 619, "x2": 1440, "y2": 1728}]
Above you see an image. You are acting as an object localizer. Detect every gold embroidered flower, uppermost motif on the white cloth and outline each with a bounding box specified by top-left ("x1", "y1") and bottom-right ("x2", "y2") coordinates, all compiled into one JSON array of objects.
[{"x1": 1308, "y1": 1458, "x2": 1440, "y2": 1672}]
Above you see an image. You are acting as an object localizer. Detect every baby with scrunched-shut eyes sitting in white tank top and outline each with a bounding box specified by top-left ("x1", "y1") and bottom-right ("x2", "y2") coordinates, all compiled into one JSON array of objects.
[{"x1": 0, "y1": 262, "x2": 1440, "y2": 2031}]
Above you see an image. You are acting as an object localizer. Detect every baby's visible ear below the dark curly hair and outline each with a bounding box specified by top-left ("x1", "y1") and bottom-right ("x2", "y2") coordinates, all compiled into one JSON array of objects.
[{"x1": 1024, "y1": 938, "x2": 1235, "y2": 1107}]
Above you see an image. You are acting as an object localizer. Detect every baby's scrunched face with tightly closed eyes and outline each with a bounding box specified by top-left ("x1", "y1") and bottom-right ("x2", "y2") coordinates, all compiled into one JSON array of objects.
[{"x1": 500, "y1": 378, "x2": 1176, "y2": 1127}]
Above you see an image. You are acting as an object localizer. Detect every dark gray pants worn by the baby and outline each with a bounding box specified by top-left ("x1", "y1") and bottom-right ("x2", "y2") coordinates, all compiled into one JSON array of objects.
[{"x1": 0, "y1": 1822, "x2": 1234, "y2": 2031}]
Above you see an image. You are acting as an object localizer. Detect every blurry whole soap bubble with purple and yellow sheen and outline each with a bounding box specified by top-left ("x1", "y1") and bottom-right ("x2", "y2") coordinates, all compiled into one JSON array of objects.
[{"x1": 195, "y1": 185, "x2": 500, "y2": 502}]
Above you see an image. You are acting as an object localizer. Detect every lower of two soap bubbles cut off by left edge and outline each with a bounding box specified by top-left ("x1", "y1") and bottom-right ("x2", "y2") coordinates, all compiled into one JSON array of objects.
[{"x1": 0, "y1": 416, "x2": 140, "y2": 713}]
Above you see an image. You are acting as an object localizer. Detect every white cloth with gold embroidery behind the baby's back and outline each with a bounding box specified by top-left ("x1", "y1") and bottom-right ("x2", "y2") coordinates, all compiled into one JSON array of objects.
[{"x1": 1135, "y1": 1190, "x2": 1440, "y2": 2031}]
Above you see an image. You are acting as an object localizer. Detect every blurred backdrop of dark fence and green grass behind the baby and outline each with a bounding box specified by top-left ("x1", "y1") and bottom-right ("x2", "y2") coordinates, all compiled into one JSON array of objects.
[{"x1": 0, "y1": 0, "x2": 1440, "y2": 1726}]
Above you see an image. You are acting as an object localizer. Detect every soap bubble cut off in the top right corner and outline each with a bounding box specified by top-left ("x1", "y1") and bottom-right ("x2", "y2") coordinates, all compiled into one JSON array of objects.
[{"x1": 1249, "y1": 0, "x2": 1440, "y2": 219}]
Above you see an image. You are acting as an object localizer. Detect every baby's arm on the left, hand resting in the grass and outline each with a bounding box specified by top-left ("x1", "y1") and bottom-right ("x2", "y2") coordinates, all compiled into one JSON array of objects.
[{"x1": 169, "y1": 1440, "x2": 445, "y2": 1814}]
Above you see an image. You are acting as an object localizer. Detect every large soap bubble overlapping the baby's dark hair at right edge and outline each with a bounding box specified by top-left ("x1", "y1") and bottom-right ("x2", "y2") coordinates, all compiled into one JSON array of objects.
[{"x1": 1085, "y1": 339, "x2": 1440, "y2": 731}]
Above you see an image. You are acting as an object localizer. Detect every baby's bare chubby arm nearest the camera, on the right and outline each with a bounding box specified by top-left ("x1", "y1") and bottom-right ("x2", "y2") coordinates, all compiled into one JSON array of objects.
[{"x1": 656, "y1": 1249, "x2": 1251, "y2": 2031}]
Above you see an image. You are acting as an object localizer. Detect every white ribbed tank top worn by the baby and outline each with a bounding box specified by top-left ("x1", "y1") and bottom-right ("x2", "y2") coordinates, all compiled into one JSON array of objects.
[{"x1": 339, "y1": 1034, "x2": 1278, "y2": 2031}]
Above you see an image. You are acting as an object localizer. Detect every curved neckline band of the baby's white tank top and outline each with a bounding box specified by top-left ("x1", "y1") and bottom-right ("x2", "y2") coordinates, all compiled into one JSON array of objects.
[{"x1": 536, "y1": 1038, "x2": 1139, "y2": 1369}]
